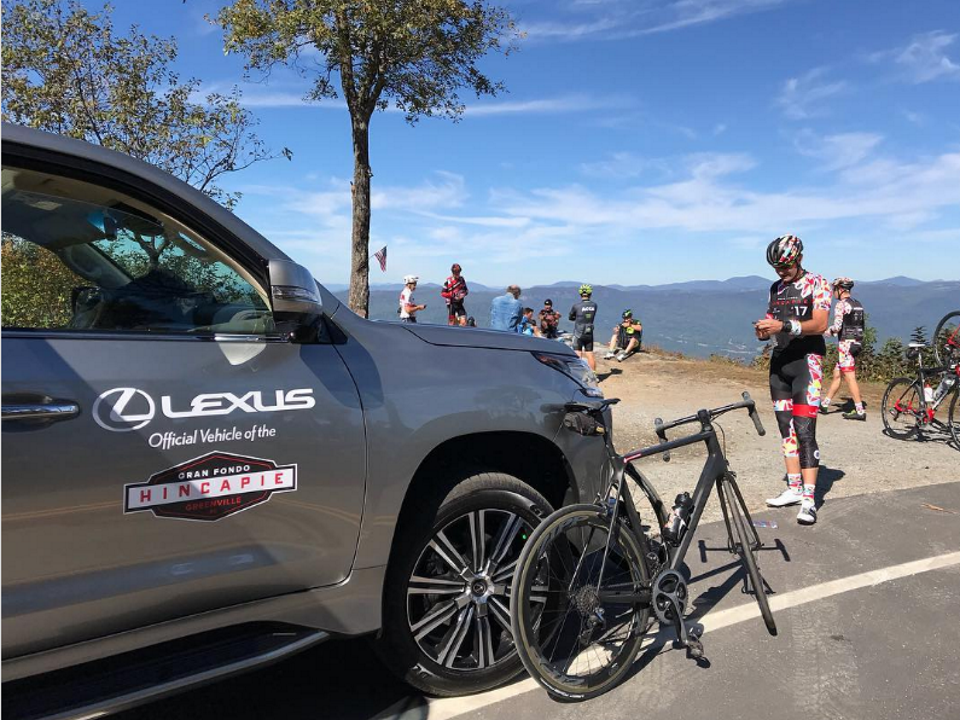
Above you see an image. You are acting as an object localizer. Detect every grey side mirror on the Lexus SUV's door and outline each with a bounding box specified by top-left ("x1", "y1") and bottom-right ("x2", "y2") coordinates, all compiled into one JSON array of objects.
[{"x1": 267, "y1": 260, "x2": 323, "y2": 343}]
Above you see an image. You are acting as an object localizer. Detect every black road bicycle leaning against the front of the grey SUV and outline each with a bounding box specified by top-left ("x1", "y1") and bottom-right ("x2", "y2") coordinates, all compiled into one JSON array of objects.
[{"x1": 511, "y1": 393, "x2": 777, "y2": 700}]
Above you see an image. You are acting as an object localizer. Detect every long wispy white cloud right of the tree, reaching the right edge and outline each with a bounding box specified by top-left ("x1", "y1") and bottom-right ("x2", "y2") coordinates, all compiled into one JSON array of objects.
[{"x1": 496, "y1": 153, "x2": 960, "y2": 234}]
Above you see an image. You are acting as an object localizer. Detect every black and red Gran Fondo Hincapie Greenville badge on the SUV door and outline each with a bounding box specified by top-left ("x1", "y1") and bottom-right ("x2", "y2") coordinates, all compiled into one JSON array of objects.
[{"x1": 123, "y1": 451, "x2": 297, "y2": 520}]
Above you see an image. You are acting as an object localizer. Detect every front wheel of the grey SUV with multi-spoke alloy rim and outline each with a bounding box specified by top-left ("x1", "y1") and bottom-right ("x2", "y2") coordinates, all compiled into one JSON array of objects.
[{"x1": 375, "y1": 472, "x2": 553, "y2": 697}]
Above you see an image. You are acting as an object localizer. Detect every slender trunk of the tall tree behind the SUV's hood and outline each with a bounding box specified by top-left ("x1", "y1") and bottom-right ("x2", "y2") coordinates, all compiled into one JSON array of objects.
[{"x1": 348, "y1": 120, "x2": 372, "y2": 317}]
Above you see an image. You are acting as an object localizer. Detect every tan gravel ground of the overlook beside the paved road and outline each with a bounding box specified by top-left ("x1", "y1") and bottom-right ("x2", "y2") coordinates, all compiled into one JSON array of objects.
[{"x1": 597, "y1": 353, "x2": 960, "y2": 521}]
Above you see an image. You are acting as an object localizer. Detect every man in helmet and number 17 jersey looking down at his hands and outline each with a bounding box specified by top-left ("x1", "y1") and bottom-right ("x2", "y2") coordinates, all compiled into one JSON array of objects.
[{"x1": 755, "y1": 235, "x2": 831, "y2": 525}]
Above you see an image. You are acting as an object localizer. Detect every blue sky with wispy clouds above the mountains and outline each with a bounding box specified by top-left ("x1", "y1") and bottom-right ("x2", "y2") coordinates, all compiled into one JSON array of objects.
[{"x1": 101, "y1": 0, "x2": 960, "y2": 285}]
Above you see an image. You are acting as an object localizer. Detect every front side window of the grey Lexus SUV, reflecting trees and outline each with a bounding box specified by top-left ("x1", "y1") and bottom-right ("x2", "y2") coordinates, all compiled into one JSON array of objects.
[{"x1": 2, "y1": 167, "x2": 274, "y2": 335}]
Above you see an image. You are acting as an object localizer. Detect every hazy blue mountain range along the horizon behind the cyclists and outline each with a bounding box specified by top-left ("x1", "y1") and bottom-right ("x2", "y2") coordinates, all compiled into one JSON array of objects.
[{"x1": 326, "y1": 275, "x2": 960, "y2": 359}]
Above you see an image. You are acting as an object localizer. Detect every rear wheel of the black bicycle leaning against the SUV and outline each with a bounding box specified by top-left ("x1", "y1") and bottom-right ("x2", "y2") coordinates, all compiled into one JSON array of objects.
[{"x1": 512, "y1": 505, "x2": 650, "y2": 700}]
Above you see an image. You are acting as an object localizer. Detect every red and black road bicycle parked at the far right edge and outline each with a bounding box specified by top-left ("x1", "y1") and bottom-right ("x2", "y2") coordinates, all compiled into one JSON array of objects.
[{"x1": 881, "y1": 318, "x2": 960, "y2": 450}]
